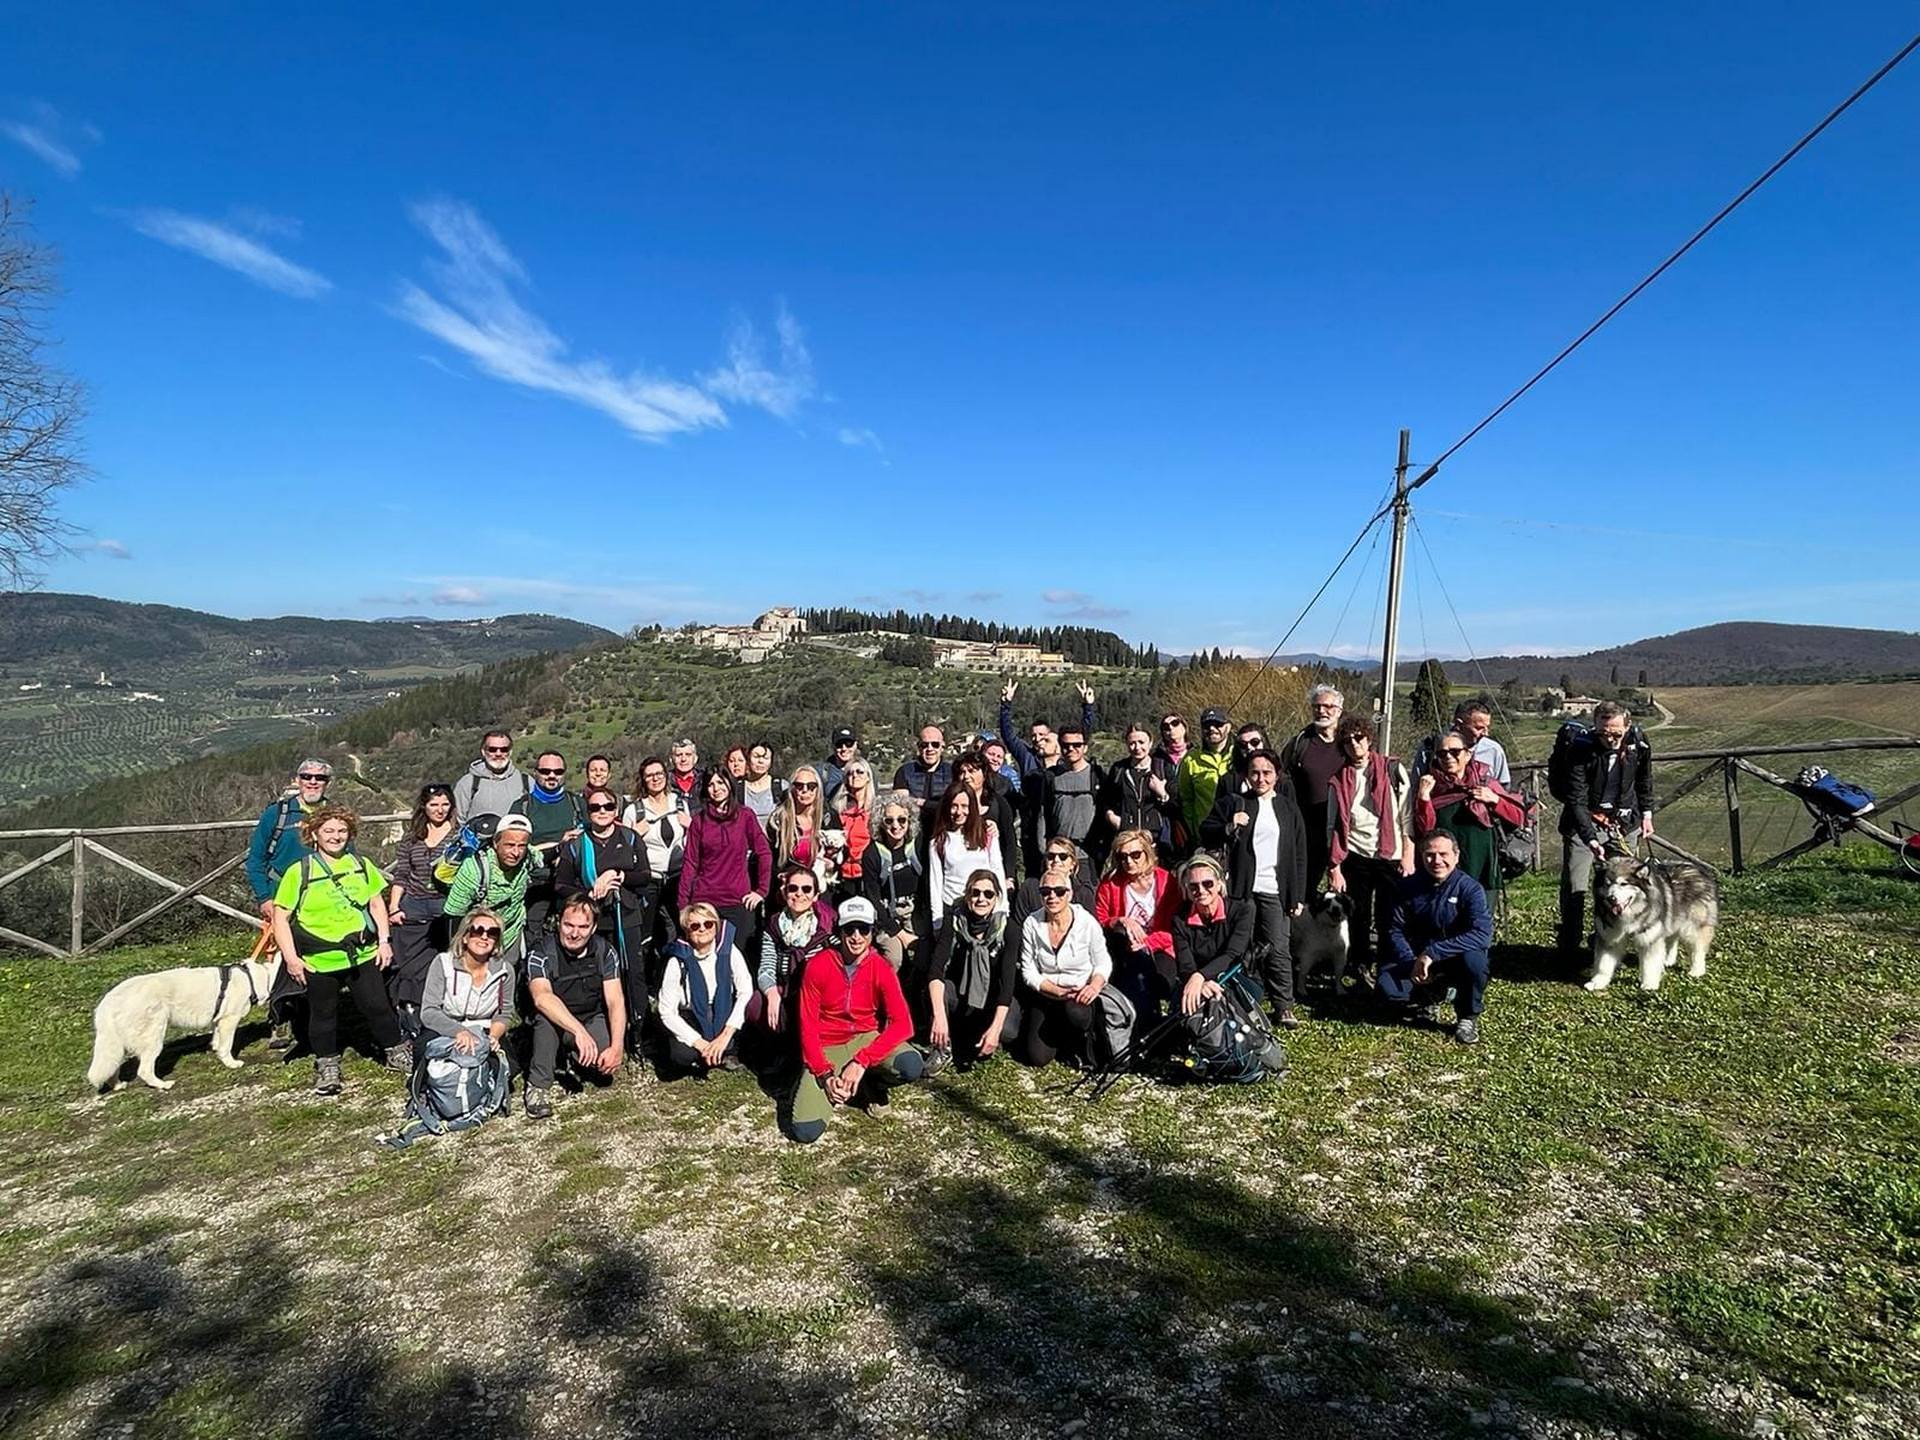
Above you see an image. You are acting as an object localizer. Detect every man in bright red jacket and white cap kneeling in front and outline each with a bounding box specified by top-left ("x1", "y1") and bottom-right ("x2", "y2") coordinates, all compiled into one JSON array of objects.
[{"x1": 793, "y1": 895, "x2": 925, "y2": 1144}]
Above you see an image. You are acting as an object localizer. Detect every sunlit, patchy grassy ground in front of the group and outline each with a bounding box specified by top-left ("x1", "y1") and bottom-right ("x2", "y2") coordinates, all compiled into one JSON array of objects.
[{"x1": 0, "y1": 851, "x2": 1920, "y2": 1440}]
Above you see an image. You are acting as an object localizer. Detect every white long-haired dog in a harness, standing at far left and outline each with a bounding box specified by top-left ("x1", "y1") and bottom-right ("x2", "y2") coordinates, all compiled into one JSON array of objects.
[{"x1": 86, "y1": 954, "x2": 280, "y2": 1091}]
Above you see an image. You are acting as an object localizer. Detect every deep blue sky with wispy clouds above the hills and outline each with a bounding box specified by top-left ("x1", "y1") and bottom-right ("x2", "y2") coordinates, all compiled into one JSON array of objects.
[{"x1": 0, "y1": 2, "x2": 1920, "y2": 653}]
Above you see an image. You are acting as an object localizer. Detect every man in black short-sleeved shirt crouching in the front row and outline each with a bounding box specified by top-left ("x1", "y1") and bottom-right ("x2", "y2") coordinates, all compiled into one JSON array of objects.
[{"x1": 526, "y1": 895, "x2": 626, "y2": 1119}]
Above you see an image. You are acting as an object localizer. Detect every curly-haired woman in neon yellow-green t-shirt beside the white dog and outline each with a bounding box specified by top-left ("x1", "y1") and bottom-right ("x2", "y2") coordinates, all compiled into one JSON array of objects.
[{"x1": 273, "y1": 804, "x2": 413, "y2": 1094}]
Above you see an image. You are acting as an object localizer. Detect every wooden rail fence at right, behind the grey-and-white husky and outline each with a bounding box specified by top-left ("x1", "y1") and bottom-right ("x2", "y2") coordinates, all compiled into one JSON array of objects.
[{"x1": 1513, "y1": 735, "x2": 1920, "y2": 876}]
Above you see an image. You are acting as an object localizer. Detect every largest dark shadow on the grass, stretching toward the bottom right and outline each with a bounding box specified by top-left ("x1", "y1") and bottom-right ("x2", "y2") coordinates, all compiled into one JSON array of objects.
[{"x1": 862, "y1": 1089, "x2": 1758, "y2": 1440}]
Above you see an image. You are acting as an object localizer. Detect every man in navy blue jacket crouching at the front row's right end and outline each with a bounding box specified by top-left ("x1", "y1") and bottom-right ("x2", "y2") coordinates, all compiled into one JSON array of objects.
[{"x1": 1379, "y1": 829, "x2": 1494, "y2": 1044}]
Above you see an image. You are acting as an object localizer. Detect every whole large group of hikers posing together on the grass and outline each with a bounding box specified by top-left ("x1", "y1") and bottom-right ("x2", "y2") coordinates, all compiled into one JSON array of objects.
[{"x1": 248, "y1": 682, "x2": 1653, "y2": 1142}]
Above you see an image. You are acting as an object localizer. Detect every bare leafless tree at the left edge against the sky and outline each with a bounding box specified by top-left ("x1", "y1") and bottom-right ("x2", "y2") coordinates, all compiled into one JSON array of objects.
[{"x1": 0, "y1": 190, "x2": 86, "y2": 589}]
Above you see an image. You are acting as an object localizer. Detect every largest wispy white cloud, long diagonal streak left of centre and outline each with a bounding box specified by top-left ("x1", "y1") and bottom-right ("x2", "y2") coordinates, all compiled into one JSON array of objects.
[{"x1": 399, "y1": 200, "x2": 726, "y2": 442}]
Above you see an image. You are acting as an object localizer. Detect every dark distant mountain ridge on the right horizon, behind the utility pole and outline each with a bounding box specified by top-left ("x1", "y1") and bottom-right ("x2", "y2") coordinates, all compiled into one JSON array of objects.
[{"x1": 1443, "y1": 620, "x2": 1920, "y2": 687}]
